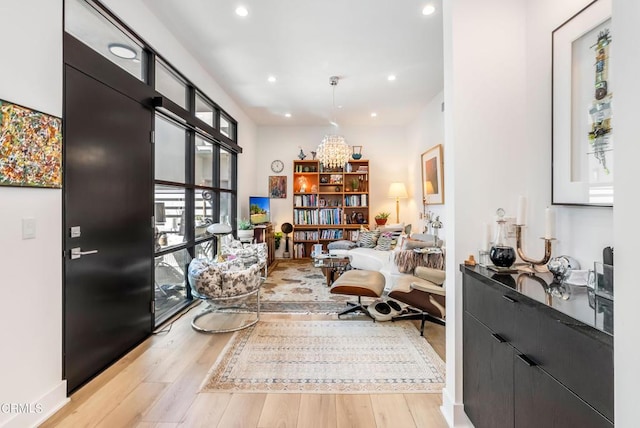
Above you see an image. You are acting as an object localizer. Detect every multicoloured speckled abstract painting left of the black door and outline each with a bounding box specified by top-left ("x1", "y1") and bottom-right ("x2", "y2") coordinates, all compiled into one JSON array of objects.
[{"x1": 0, "y1": 100, "x2": 62, "y2": 189}]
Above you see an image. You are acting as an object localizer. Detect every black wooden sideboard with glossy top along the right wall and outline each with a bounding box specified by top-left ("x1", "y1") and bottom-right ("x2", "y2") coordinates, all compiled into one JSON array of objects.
[{"x1": 460, "y1": 266, "x2": 613, "y2": 428}]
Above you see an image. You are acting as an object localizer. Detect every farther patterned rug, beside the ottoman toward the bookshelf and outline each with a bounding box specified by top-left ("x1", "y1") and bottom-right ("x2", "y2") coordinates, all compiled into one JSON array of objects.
[{"x1": 260, "y1": 259, "x2": 356, "y2": 314}]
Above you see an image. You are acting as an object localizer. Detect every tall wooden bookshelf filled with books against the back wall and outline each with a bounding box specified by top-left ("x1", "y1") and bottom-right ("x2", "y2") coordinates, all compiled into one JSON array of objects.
[{"x1": 292, "y1": 160, "x2": 370, "y2": 258}]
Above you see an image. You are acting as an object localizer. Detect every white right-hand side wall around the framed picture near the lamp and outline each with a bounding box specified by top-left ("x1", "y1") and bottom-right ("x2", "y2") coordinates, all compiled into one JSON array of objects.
[{"x1": 406, "y1": 92, "x2": 448, "y2": 237}]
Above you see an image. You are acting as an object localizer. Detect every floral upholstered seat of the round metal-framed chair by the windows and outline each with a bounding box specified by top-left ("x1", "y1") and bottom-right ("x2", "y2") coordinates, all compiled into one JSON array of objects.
[{"x1": 188, "y1": 258, "x2": 262, "y2": 299}]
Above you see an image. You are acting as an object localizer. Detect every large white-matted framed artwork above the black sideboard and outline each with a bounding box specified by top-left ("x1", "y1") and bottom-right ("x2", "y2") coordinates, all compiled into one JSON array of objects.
[{"x1": 551, "y1": 0, "x2": 615, "y2": 207}]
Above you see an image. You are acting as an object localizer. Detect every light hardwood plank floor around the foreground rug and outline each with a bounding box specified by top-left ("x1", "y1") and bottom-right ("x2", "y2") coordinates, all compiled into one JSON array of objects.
[{"x1": 42, "y1": 308, "x2": 447, "y2": 428}]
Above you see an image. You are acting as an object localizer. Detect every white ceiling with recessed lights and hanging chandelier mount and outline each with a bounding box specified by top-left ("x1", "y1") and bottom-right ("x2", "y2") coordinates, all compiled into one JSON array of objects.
[{"x1": 143, "y1": 0, "x2": 443, "y2": 126}]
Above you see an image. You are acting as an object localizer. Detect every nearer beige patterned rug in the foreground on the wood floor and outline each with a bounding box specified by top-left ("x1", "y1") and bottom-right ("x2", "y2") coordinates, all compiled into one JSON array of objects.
[{"x1": 202, "y1": 320, "x2": 445, "y2": 394}]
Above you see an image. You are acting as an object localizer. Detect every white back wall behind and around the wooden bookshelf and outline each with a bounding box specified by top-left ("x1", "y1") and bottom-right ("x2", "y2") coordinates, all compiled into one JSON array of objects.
[{"x1": 254, "y1": 126, "x2": 422, "y2": 257}]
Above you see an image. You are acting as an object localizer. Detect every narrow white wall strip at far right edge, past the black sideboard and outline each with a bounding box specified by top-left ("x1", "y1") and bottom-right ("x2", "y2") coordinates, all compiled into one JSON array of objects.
[{"x1": 612, "y1": 0, "x2": 640, "y2": 427}]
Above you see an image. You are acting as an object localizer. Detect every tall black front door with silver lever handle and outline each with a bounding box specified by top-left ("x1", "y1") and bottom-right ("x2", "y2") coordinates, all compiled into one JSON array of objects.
[{"x1": 64, "y1": 65, "x2": 153, "y2": 392}]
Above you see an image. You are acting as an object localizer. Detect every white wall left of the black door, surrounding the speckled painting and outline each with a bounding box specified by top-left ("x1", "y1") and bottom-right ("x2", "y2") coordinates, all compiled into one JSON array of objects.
[{"x1": 0, "y1": 0, "x2": 66, "y2": 427}]
